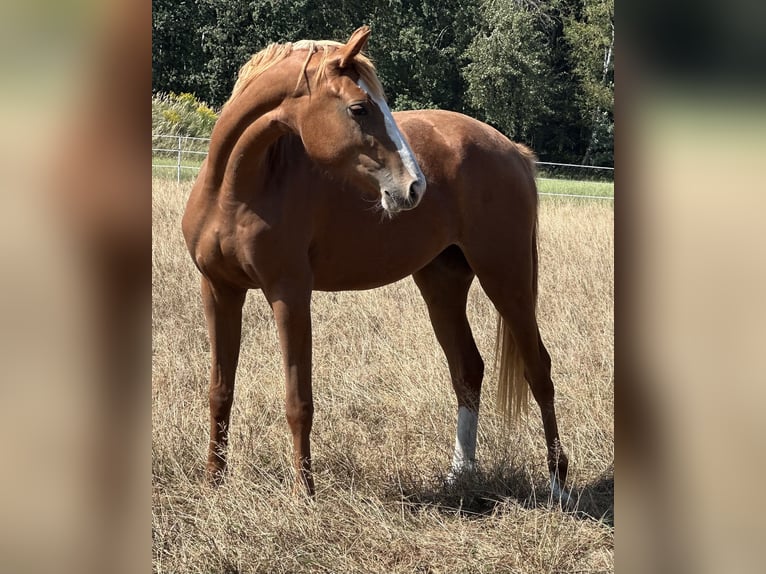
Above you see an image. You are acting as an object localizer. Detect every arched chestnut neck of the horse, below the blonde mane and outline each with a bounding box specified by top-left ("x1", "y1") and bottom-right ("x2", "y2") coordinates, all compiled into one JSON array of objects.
[{"x1": 207, "y1": 66, "x2": 298, "y2": 198}]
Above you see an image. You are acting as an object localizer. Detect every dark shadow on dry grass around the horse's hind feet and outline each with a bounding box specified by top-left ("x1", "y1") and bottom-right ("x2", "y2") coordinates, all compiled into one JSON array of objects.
[{"x1": 389, "y1": 465, "x2": 614, "y2": 527}]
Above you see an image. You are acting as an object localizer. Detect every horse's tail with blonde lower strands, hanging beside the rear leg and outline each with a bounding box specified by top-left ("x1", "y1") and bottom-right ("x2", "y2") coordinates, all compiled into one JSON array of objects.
[{"x1": 495, "y1": 143, "x2": 538, "y2": 426}]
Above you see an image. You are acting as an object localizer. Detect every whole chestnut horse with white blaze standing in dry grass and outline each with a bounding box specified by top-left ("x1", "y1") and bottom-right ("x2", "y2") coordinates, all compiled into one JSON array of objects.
[{"x1": 183, "y1": 26, "x2": 568, "y2": 496}]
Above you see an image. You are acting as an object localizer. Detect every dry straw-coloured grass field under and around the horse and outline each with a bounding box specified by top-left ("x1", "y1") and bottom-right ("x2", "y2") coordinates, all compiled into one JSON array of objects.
[{"x1": 152, "y1": 179, "x2": 614, "y2": 573}]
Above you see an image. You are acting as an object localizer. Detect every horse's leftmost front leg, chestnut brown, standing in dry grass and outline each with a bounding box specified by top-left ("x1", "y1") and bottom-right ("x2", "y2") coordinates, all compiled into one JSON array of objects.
[{"x1": 202, "y1": 277, "x2": 247, "y2": 485}]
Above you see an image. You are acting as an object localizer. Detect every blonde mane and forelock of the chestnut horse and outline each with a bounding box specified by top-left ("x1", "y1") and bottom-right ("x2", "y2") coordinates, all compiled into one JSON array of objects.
[{"x1": 226, "y1": 40, "x2": 385, "y2": 105}]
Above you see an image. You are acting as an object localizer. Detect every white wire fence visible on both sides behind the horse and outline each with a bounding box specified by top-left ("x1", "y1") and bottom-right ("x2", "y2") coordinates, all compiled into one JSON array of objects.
[{"x1": 152, "y1": 135, "x2": 614, "y2": 200}]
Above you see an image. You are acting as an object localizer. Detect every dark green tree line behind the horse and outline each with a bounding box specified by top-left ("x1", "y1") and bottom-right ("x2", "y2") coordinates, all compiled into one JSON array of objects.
[{"x1": 152, "y1": 0, "x2": 614, "y2": 166}]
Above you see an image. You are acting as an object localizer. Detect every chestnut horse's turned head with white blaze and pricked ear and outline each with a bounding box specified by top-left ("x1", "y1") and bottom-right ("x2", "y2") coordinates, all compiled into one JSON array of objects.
[{"x1": 296, "y1": 26, "x2": 426, "y2": 214}]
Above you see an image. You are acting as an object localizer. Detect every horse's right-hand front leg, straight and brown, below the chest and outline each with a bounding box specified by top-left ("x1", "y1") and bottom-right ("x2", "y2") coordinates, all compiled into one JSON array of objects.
[{"x1": 268, "y1": 288, "x2": 314, "y2": 497}]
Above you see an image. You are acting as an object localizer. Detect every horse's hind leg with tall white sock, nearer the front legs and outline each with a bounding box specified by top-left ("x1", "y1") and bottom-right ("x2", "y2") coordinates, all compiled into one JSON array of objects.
[{"x1": 413, "y1": 246, "x2": 484, "y2": 481}]
